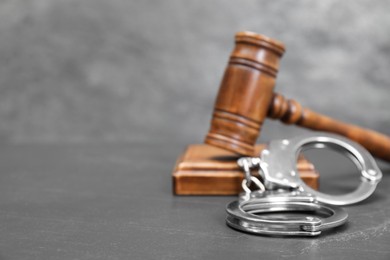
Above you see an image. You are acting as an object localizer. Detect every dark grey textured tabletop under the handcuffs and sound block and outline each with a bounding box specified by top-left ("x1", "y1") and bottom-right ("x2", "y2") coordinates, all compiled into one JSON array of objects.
[{"x1": 0, "y1": 143, "x2": 390, "y2": 259}]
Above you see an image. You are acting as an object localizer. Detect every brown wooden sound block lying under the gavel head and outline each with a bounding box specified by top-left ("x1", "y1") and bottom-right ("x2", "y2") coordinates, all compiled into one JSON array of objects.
[{"x1": 172, "y1": 144, "x2": 319, "y2": 195}]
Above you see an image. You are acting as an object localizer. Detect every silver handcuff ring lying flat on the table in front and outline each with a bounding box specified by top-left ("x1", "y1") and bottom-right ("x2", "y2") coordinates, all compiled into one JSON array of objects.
[{"x1": 226, "y1": 192, "x2": 348, "y2": 236}]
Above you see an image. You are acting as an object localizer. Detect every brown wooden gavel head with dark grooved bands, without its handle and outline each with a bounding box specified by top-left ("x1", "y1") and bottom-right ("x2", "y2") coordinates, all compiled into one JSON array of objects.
[{"x1": 205, "y1": 32, "x2": 285, "y2": 156}]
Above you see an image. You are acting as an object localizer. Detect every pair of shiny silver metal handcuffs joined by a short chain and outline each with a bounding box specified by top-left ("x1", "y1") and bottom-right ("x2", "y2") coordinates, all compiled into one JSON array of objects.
[{"x1": 226, "y1": 132, "x2": 382, "y2": 236}]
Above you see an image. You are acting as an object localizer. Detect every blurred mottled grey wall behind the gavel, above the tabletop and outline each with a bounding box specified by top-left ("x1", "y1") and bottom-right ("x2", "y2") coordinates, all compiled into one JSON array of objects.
[{"x1": 0, "y1": 0, "x2": 390, "y2": 143}]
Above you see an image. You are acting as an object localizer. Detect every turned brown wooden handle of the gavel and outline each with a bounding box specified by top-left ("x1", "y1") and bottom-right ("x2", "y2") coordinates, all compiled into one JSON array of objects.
[{"x1": 268, "y1": 93, "x2": 390, "y2": 161}]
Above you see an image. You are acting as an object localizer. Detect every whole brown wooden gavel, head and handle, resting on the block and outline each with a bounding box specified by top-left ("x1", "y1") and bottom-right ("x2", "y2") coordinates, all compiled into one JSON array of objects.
[{"x1": 205, "y1": 32, "x2": 390, "y2": 161}]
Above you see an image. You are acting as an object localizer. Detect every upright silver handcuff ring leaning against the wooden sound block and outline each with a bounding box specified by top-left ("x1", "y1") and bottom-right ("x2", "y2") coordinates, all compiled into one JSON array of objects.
[{"x1": 260, "y1": 133, "x2": 382, "y2": 205}]
